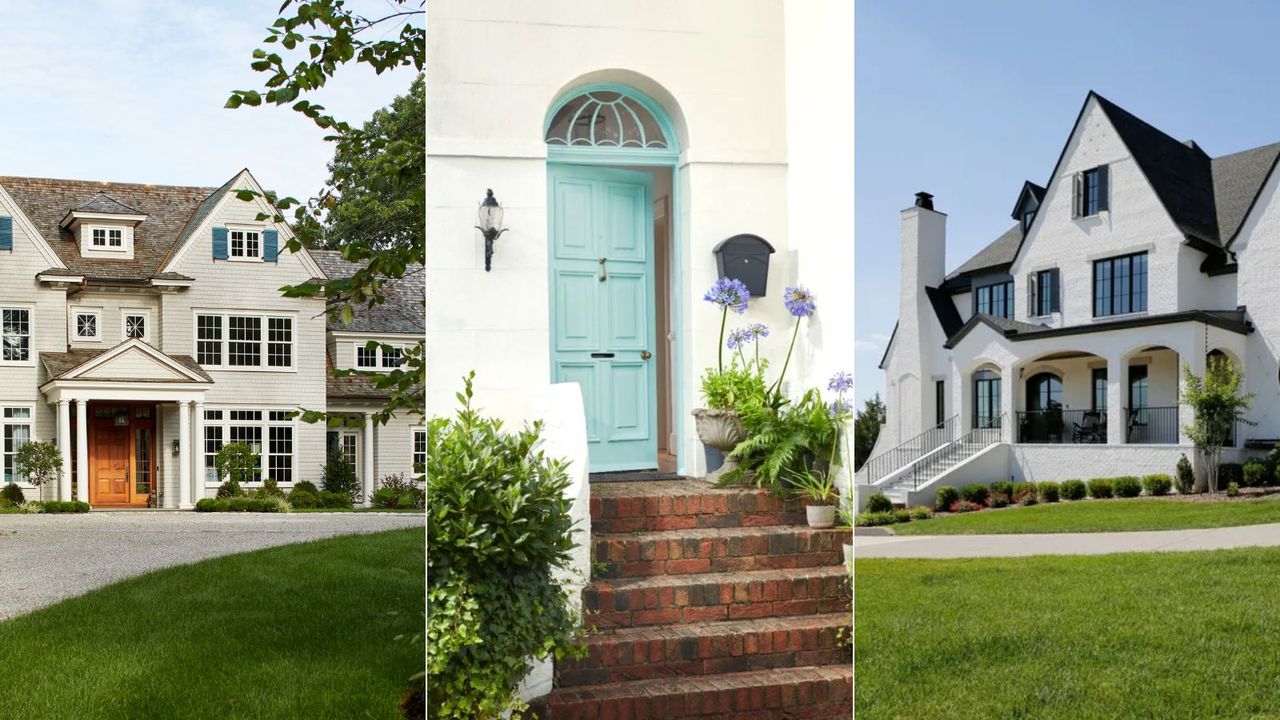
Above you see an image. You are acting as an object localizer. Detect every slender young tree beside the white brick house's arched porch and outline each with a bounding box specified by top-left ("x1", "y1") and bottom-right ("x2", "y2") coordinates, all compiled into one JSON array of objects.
[{"x1": 1183, "y1": 356, "x2": 1254, "y2": 492}]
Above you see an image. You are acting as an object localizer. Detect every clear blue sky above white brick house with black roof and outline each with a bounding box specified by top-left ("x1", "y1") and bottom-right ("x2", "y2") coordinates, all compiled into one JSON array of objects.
[{"x1": 855, "y1": 0, "x2": 1280, "y2": 404}]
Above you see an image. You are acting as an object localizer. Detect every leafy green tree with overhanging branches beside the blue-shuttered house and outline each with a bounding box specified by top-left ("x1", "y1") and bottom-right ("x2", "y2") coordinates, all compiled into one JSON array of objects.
[{"x1": 227, "y1": 0, "x2": 426, "y2": 424}]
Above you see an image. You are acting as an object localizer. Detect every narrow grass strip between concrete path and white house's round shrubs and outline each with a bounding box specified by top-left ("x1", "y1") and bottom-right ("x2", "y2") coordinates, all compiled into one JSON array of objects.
[{"x1": 893, "y1": 498, "x2": 1280, "y2": 536}]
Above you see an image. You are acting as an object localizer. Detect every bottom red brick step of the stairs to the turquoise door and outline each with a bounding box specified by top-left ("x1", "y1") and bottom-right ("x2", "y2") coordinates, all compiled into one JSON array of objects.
[{"x1": 547, "y1": 665, "x2": 854, "y2": 720}]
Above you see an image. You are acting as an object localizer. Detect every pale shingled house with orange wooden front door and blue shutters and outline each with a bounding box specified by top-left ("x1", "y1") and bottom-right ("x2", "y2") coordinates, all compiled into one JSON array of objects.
[{"x1": 0, "y1": 170, "x2": 425, "y2": 507}]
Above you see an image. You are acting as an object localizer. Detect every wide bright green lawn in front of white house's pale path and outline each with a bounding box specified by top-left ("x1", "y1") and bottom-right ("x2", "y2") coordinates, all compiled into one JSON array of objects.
[{"x1": 854, "y1": 548, "x2": 1280, "y2": 720}]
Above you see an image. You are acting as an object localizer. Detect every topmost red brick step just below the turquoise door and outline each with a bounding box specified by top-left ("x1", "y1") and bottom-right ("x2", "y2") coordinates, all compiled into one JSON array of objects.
[{"x1": 591, "y1": 479, "x2": 805, "y2": 534}]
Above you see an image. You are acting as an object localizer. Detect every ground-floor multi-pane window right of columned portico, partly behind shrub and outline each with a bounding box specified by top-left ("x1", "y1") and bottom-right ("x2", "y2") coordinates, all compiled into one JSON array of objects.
[{"x1": 205, "y1": 410, "x2": 296, "y2": 484}]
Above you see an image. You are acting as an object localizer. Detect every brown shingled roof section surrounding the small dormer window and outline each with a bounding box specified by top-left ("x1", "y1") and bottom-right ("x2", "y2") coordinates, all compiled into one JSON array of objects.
[{"x1": 0, "y1": 177, "x2": 214, "y2": 282}]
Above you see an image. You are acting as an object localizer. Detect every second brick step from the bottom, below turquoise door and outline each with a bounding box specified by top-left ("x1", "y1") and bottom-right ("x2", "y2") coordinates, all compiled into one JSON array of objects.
[{"x1": 556, "y1": 612, "x2": 852, "y2": 687}]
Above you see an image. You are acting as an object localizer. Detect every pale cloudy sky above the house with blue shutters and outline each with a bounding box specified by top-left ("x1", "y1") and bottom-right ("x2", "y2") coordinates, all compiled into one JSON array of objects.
[{"x1": 0, "y1": 0, "x2": 413, "y2": 199}]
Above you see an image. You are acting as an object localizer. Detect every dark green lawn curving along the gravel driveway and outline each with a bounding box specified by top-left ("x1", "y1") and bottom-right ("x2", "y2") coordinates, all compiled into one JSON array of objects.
[{"x1": 0, "y1": 529, "x2": 426, "y2": 720}]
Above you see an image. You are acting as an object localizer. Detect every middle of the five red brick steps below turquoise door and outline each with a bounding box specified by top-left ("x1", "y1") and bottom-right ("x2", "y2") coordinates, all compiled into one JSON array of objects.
[{"x1": 582, "y1": 561, "x2": 849, "y2": 628}]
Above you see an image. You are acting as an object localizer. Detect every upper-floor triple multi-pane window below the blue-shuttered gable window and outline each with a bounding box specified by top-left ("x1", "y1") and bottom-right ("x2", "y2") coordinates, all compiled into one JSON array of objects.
[{"x1": 196, "y1": 315, "x2": 293, "y2": 369}]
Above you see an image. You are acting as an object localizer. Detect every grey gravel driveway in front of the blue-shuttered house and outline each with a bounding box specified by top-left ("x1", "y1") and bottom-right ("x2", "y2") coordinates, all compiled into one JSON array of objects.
[{"x1": 0, "y1": 511, "x2": 425, "y2": 620}]
